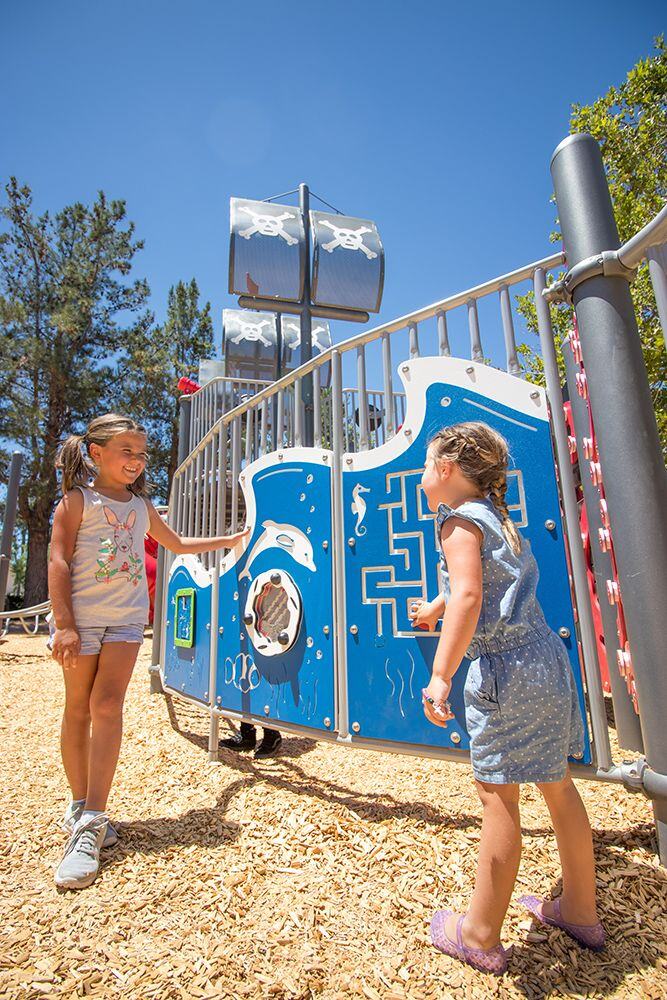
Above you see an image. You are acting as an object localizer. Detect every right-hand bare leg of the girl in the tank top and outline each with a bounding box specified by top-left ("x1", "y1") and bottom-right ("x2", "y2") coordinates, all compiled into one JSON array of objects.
[{"x1": 86, "y1": 642, "x2": 139, "y2": 810}]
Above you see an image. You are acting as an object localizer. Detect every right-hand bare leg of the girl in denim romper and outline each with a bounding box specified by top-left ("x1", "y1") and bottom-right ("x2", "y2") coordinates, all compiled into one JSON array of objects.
[{"x1": 537, "y1": 773, "x2": 598, "y2": 925}]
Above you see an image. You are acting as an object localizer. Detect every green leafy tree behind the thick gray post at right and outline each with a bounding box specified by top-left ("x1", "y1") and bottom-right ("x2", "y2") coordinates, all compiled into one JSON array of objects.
[{"x1": 517, "y1": 37, "x2": 667, "y2": 449}]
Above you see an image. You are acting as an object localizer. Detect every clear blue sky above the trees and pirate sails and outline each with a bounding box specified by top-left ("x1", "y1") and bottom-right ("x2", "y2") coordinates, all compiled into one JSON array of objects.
[{"x1": 0, "y1": 0, "x2": 665, "y2": 376}]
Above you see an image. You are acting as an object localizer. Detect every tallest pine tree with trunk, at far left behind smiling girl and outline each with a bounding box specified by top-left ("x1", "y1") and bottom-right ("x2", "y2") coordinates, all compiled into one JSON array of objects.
[{"x1": 0, "y1": 178, "x2": 151, "y2": 604}]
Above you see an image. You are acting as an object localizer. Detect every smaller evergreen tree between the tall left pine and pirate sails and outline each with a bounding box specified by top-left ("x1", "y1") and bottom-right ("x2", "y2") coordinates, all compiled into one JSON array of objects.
[{"x1": 120, "y1": 278, "x2": 213, "y2": 501}]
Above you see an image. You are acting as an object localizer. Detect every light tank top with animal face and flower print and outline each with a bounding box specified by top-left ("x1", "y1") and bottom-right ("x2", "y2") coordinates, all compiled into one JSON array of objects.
[{"x1": 70, "y1": 486, "x2": 149, "y2": 628}]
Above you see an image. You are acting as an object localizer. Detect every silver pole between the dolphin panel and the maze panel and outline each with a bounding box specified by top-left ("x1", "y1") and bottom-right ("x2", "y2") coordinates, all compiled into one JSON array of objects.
[{"x1": 331, "y1": 351, "x2": 350, "y2": 738}]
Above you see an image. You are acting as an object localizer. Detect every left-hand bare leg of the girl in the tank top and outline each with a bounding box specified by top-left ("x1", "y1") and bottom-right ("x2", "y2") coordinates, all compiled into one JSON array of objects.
[{"x1": 60, "y1": 653, "x2": 98, "y2": 799}]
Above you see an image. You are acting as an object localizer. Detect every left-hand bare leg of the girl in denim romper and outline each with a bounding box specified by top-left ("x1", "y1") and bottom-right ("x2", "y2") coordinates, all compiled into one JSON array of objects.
[{"x1": 445, "y1": 781, "x2": 521, "y2": 948}]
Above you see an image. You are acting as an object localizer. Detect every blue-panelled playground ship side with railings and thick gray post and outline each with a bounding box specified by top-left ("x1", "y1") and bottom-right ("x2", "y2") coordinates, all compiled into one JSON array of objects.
[{"x1": 144, "y1": 136, "x2": 667, "y2": 863}]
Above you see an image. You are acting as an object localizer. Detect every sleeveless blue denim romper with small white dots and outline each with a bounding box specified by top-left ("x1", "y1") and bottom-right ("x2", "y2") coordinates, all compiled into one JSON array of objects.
[{"x1": 437, "y1": 500, "x2": 584, "y2": 785}]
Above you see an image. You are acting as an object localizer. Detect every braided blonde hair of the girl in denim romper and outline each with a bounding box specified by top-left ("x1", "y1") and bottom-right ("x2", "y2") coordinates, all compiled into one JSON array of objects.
[{"x1": 429, "y1": 420, "x2": 521, "y2": 555}]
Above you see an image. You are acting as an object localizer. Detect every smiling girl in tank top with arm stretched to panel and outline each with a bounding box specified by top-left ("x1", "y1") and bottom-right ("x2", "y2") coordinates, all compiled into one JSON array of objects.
[{"x1": 49, "y1": 413, "x2": 247, "y2": 889}]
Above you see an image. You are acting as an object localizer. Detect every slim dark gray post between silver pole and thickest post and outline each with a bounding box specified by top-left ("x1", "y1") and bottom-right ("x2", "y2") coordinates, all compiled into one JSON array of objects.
[{"x1": 563, "y1": 336, "x2": 644, "y2": 753}]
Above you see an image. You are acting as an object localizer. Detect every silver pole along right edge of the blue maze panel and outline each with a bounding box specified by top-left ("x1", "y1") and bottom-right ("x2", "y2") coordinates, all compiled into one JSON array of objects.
[{"x1": 534, "y1": 267, "x2": 612, "y2": 769}]
